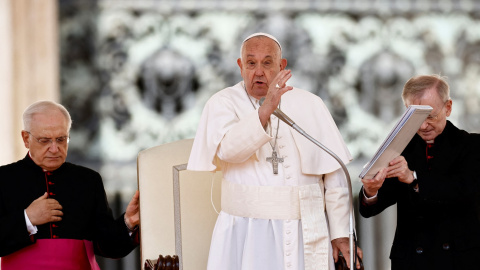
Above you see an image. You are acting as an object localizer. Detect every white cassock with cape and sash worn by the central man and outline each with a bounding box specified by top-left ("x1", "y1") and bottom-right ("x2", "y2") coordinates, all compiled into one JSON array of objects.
[{"x1": 188, "y1": 82, "x2": 352, "y2": 270}]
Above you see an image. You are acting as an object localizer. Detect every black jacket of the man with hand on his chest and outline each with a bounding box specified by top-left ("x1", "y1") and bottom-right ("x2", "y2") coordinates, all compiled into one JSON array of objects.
[{"x1": 0, "y1": 154, "x2": 138, "y2": 258}]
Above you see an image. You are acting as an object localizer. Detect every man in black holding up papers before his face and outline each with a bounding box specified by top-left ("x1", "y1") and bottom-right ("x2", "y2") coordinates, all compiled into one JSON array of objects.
[{"x1": 359, "y1": 75, "x2": 480, "y2": 270}]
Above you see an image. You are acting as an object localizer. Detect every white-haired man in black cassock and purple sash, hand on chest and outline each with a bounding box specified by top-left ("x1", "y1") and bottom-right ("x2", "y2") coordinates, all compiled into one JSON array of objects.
[{"x1": 0, "y1": 101, "x2": 139, "y2": 270}]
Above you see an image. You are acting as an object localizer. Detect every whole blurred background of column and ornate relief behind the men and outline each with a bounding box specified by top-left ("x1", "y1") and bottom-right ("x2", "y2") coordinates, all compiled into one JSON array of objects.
[{"x1": 0, "y1": 0, "x2": 480, "y2": 270}]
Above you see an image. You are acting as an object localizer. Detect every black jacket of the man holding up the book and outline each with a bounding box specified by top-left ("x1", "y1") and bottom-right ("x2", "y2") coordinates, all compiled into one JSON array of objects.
[{"x1": 359, "y1": 121, "x2": 480, "y2": 270}]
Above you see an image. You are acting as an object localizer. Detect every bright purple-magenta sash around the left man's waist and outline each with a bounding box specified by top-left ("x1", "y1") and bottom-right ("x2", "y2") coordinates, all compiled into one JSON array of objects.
[{"x1": 1, "y1": 239, "x2": 100, "y2": 270}]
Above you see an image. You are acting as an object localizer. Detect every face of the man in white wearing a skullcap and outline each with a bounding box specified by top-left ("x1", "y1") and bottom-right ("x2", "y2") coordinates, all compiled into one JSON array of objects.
[{"x1": 237, "y1": 36, "x2": 287, "y2": 99}]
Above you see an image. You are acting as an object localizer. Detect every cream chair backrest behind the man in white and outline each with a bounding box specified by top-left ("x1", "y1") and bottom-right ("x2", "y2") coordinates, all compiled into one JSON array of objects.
[{"x1": 137, "y1": 139, "x2": 222, "y2": 270}]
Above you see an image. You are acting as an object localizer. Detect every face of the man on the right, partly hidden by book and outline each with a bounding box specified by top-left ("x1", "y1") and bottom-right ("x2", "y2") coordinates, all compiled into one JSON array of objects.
[{"x1": 406, "y1": 88, "x2": 452, "y2": 141}]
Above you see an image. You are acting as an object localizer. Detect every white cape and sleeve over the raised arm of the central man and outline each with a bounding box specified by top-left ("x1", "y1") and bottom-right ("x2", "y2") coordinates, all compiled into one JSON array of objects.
[{"x1": 187, "y1": 92, "x2": 272, "y2": 171}]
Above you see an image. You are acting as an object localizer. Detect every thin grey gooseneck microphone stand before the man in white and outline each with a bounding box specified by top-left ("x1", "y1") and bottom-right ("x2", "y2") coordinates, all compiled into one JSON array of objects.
[{"x1": 273, "y1": 109, "x2": 357, "y2": 270}]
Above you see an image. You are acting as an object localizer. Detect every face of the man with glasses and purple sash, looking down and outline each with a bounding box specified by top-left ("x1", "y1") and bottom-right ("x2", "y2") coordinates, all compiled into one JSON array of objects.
[{"x1": 22, "y1": 110, "x2": 68, "y2": 171}]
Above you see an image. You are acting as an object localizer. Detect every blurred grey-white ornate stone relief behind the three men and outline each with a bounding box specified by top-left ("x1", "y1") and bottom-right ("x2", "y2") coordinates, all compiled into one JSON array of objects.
[{"x1": 60, "y1": 0, "x2": 480, "y2": 192}]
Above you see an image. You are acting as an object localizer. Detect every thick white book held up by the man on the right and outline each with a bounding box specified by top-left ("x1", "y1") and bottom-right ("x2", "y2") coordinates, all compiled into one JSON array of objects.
[{"x1": 359, "y1": 105, "x2": 432, "y2": 179}]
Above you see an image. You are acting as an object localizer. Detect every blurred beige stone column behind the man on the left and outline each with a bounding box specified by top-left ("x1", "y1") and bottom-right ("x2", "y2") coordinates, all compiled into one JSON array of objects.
[{"x1": 0, "y1": 0, "x2": 60, "y2": 165}]
